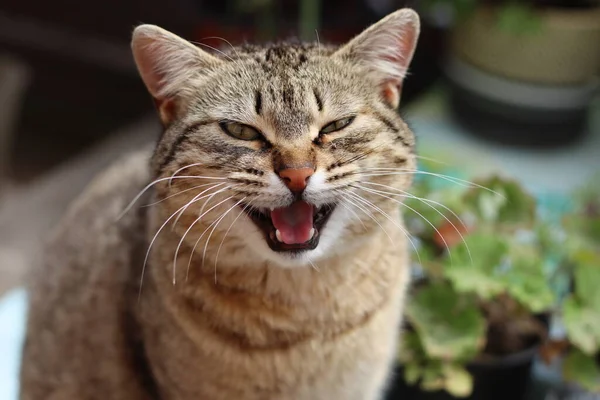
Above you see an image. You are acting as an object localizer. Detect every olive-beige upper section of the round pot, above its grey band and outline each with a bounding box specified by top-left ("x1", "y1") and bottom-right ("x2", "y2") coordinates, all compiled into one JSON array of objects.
[{"x1": 451, "y1": 7, "x2": 600, "y2": 86}]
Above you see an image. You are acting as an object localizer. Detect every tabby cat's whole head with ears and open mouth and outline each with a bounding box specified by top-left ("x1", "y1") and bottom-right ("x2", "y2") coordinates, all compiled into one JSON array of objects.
[{"x1": 132, "y1": 9, "x2": 419, "y2": 265}]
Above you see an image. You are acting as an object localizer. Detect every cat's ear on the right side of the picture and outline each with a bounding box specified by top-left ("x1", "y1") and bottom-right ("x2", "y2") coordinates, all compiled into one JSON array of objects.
[{"x1": 334, "y1": 8, "x2": 420, "y2": 108}]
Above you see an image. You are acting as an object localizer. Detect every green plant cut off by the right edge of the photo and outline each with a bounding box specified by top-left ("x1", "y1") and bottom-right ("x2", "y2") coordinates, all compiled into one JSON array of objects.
[{"x1": 542, "y1": 178, "x2": 600, "y2": 395}]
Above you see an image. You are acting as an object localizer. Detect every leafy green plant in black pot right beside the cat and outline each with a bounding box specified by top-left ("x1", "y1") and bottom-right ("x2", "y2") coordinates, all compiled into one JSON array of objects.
[{"x1": 388, "y1": 171, "x2": 554, "y2": 400}]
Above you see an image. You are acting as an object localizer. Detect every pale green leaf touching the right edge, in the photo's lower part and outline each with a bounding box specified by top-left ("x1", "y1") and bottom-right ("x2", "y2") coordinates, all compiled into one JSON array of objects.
[{"x1": 563, "y1": 296, "x2": 600, "y2": 356}]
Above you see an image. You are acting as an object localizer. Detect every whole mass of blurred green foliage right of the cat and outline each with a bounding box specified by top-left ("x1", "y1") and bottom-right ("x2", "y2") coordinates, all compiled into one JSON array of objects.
[{"x1": 399, "y1": 166, "x2": 600, "y2": 397}]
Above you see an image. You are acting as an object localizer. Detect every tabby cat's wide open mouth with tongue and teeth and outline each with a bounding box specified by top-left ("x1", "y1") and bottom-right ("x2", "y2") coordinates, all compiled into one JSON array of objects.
[{"x1": 246, "y1": 200, "x2": 335, "y2": 252}]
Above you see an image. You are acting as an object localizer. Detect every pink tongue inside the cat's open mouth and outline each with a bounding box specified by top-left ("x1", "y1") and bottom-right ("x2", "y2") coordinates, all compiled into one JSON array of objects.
[{"x1": 271, "y1": 201, "x2": 313, "y2": 244}]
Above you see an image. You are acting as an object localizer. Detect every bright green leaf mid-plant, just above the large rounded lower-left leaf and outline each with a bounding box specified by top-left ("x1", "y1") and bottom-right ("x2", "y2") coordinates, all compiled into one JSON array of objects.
[{"x1": 444, "y1": 233, "x2": 507, "y2": 299}]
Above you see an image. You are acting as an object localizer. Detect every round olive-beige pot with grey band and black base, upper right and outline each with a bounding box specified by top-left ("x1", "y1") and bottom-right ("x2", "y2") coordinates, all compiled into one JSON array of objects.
[{"x1": 426, "y1": 0, "x2": 600, "y2": 146}]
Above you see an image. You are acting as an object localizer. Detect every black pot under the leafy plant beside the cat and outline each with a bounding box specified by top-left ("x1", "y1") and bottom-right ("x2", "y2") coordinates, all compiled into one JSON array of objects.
[{"x1": 385, "y1": 346, "x2": 538, "y2": 400}]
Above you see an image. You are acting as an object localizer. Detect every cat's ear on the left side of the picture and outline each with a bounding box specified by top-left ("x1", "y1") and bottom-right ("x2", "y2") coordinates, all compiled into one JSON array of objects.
[{"x1": 131, "y1": 25, "x2": 222, "y2": 124}]
